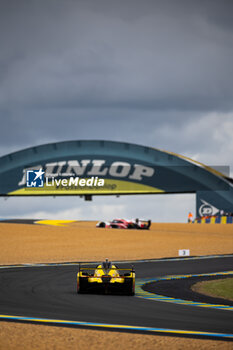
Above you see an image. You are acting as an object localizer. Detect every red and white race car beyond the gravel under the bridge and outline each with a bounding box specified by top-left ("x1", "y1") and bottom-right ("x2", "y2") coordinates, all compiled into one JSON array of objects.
[{"x1": 96, "y1": 219, "x2": 151, "y2": 230}]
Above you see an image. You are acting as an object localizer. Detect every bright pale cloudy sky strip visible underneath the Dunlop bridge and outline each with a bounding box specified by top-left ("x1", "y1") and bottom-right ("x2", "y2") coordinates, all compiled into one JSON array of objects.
[{"x1": 0, "y1": 194, "x2": 197, "y2": 222}]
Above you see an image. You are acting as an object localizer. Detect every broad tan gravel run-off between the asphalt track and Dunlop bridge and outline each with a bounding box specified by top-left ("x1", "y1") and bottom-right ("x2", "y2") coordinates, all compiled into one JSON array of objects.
[{"x1": 0, "y1": 222, "x2": 233, "y2": 264}]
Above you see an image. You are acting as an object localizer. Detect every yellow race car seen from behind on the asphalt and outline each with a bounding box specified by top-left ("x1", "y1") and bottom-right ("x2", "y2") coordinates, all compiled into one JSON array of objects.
[{"x1": 77, "y1": 259, "x2": 135, "y2": 295}]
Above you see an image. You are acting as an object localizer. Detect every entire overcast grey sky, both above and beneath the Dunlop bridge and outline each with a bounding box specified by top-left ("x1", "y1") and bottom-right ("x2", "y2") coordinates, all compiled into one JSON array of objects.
[{"x1": 0, "y1": 0, "x2": 233, "y2": 222}]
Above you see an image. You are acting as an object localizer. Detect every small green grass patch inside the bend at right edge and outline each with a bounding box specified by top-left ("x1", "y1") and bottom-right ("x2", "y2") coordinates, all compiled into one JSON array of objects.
[{"x1": 192, "y1": 278, "x2": 233, "y2": 300}]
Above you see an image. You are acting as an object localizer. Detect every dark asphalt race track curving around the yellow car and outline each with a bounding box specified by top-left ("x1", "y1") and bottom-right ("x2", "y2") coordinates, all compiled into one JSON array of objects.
[{"x1": 0, "y1": 257, "x2": 233, "y2": 340}]
